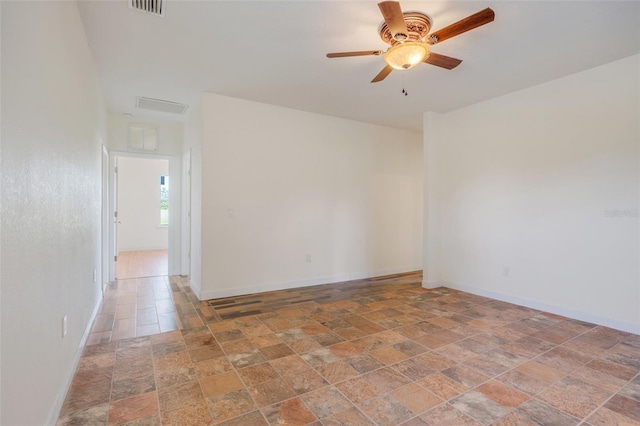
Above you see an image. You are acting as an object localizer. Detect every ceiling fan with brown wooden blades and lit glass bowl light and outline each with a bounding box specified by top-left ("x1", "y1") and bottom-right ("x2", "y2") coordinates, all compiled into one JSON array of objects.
[{"x1": 327, "y1": 1, "x2": 495, "y2": 83}]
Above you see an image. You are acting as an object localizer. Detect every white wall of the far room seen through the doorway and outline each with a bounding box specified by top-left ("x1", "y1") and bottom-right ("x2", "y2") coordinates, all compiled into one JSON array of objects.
[{"x1": 118, "y1": 157, "x2": 173, "y2": 252}]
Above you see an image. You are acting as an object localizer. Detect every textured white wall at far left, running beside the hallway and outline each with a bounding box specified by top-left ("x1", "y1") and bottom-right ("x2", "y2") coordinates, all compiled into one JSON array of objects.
[{"x1": 0, "y1": 2, "x2": 106, "y2": 425}]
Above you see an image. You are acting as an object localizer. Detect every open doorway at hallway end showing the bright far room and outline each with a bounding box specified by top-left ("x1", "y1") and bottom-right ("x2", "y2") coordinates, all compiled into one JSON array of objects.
[{"x1": 114, "y1": 156, "x2": 172, "y2": 280}]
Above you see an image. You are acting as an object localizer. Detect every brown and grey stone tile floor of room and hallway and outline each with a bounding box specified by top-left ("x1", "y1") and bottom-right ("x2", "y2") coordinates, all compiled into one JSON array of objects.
[{"x1": 58, "y1": 273, "x2": 640, "y2": 426}]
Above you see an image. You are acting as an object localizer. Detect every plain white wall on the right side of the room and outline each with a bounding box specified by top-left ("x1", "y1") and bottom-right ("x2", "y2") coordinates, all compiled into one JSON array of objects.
[{"x1": 425, "y1": 55, "x2": 640, "y2": 333}]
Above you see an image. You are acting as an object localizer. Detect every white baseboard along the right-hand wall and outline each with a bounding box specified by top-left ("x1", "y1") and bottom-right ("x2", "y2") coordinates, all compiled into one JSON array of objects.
[{"x1": 444, "y1": 282, "x2": 640, "y2": 334}]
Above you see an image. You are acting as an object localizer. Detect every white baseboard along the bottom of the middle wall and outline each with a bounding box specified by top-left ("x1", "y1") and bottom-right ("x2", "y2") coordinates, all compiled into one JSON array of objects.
[{"x1": 196, "y1": 266, "x2": 422, "y2": 300}]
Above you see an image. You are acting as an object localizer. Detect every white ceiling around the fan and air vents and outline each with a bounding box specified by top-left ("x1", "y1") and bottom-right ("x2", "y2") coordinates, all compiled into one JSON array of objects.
[{"x1": 79, "y1": 0, "x2": 640, "y2": 131}]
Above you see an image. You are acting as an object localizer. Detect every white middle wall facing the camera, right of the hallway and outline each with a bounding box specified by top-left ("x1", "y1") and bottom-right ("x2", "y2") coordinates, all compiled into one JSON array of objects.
[{"x1": 194, "y1": 94, "x2": 422, "y2": 298}]
